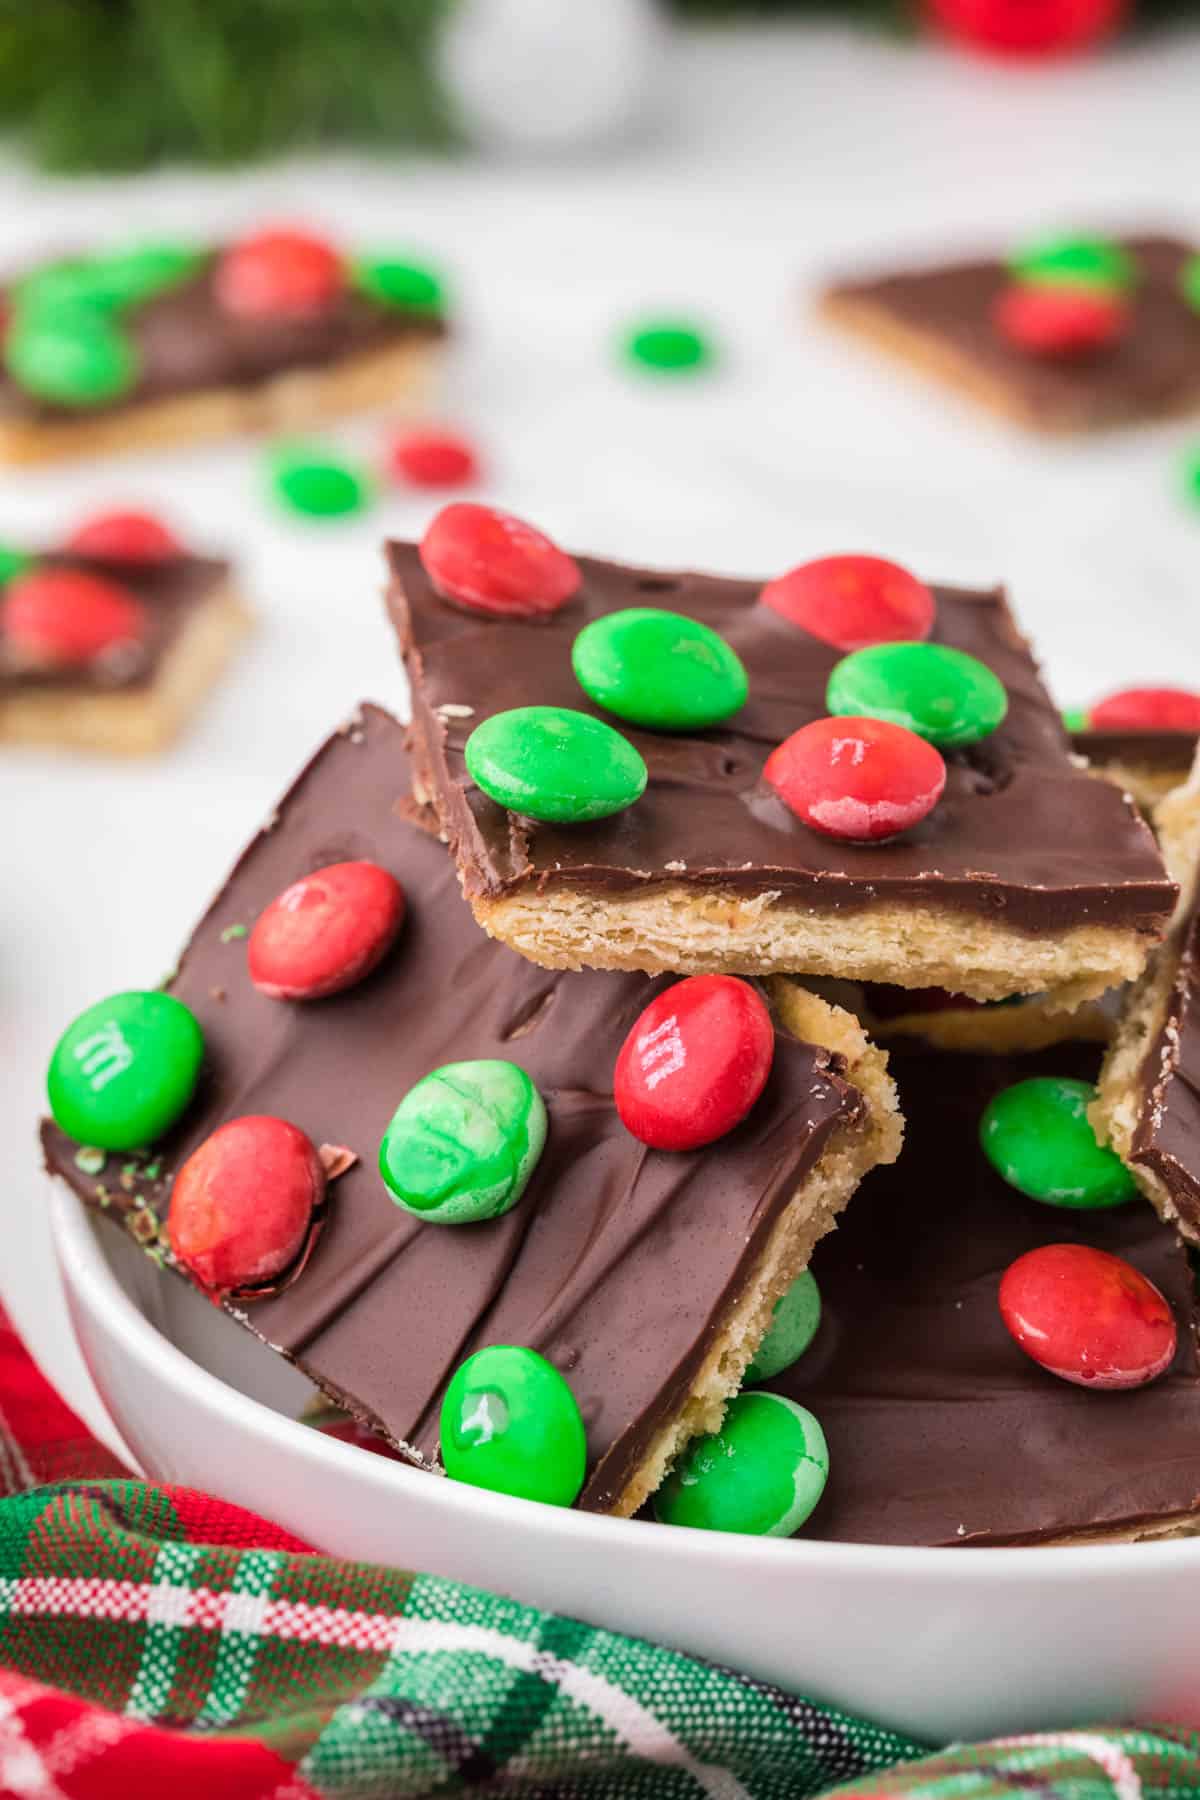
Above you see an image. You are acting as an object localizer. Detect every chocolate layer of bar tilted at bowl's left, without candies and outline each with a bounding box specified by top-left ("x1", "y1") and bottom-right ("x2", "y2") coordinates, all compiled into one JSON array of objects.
[{"x1": 43, "y1": 707, "x2": 862, "y2": 1510}]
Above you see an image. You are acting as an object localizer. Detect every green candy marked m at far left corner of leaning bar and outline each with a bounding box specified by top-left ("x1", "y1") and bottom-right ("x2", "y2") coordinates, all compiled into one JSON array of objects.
[{"x1": 47, "y1": 992, "x2": 203, "y2": 1150}]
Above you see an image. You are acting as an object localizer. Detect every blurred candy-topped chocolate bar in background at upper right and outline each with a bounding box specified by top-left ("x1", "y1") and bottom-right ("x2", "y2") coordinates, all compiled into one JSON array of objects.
[{"x1": 820, "y1": 238, "x2": 1200, "y2": 434}]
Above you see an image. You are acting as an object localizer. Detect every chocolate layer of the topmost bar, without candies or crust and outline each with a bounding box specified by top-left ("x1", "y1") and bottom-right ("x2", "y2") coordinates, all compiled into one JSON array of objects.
[{"x1": 389, "y1": 544, "x2": 1173, "y2": 936}]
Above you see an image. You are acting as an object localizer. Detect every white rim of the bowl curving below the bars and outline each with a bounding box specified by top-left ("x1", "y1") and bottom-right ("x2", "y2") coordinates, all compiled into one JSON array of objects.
[{"x1": 50, "y1": 1181, "x2": 1200, "y2": 1586}]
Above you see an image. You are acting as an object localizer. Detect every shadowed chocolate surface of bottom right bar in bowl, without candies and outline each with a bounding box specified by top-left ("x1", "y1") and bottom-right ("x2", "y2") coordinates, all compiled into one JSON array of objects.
[{"x1": 770, "y1": 1049, "x2": 1200, "y2": 1544}]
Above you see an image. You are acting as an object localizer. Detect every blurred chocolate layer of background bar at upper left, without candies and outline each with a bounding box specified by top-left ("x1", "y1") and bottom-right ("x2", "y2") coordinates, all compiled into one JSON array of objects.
[{"x1": 0, "y1": 256, "x2": 446, "y2": 421}]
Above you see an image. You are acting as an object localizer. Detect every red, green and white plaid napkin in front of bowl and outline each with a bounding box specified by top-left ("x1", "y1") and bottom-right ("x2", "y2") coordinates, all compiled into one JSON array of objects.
[{"x1": 0, "y1": 1314, "x2": 1200, "y2": 1800}]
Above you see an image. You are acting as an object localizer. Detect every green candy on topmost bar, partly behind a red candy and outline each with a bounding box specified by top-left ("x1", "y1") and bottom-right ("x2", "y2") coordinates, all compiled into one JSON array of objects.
[{"x1": 826, "y1": 644, "x2": 1007, "y2": 749}]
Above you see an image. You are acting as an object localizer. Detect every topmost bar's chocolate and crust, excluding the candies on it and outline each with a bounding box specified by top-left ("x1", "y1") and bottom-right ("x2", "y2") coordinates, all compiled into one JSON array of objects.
[{"x1": 389, "y1": 544, "x2": 1173, "y2": 1003}]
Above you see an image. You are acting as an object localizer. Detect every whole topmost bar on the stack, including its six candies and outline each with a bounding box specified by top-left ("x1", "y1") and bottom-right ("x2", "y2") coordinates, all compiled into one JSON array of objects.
[{"x1": 389, "y1": 506, "x2": 1173, "y2": 1006}]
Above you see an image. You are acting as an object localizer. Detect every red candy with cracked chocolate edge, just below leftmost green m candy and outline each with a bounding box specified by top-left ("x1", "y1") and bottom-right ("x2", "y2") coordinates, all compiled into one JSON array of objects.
[{"x1": 167, "y1": 1114, "x2": 326, "y2": 1294}]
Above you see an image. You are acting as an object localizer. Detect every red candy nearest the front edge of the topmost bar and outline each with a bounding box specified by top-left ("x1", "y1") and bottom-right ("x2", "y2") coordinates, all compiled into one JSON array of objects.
[{"x1": 763, "y1": 718, "x2": 946, "y2": 842}]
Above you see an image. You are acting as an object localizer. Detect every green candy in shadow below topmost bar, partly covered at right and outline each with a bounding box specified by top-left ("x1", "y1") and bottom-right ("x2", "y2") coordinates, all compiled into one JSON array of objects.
[{"x1": 979, "y1": 1075, "x2": 1137, "y2": 1211}]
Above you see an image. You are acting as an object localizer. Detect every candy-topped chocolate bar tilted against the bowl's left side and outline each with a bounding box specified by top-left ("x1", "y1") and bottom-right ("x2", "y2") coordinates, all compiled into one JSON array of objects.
[{"x1": 43, "y1": 707, "x2": 900, "y2": 1514}]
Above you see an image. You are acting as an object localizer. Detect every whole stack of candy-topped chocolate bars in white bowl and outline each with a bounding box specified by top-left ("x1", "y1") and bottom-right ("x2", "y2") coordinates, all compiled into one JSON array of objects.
[{"x1": 43, "y1": 504, "x2": 1200, "y2": 1544}]
